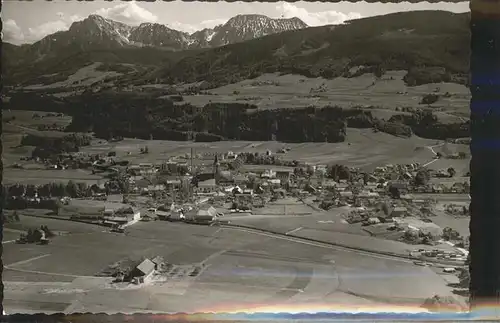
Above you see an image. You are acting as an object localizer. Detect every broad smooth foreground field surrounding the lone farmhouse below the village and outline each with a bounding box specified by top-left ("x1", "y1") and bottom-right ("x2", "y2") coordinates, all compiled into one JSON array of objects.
[{"x1": 3, "y1": 217, "x2": 464, "y2": 312}]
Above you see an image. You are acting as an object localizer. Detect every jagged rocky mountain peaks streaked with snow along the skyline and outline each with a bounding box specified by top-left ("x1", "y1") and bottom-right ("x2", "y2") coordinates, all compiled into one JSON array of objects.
[{"x1": 5, "y1": 15, "x2": 308, "y2": 59}]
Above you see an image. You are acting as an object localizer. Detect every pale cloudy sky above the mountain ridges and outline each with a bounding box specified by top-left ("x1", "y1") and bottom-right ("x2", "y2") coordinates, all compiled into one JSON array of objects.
[{"x1": 1, "y1": 0, "x2": 469, "y2": 44}]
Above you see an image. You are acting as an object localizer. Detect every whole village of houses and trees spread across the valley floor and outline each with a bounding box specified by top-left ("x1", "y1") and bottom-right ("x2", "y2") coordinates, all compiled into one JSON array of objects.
[{"x1": 4, "y1": 139, "x2": 469, "y2": 281}]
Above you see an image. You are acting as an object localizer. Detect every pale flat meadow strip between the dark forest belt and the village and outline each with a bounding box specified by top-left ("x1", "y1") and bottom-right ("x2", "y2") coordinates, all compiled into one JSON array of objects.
[{"x1": 76, "y1": 129, "x2": 444, "y2": 168}]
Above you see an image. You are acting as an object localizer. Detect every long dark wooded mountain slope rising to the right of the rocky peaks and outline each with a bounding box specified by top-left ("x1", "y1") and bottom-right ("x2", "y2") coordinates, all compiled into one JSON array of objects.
[{"x1": 150, "y1": 11, "x2": 469, "y2": 84}]
